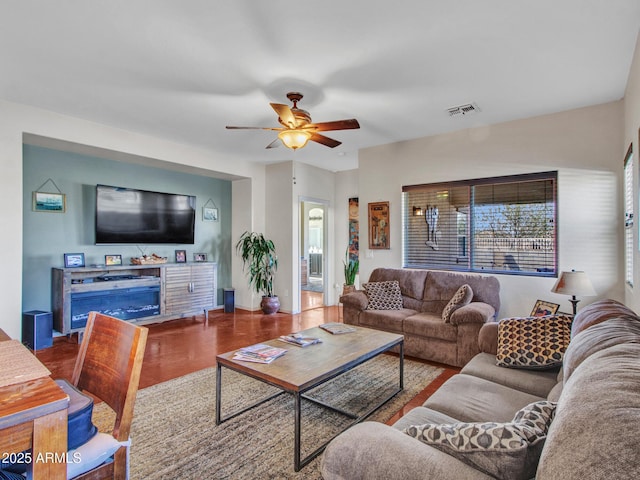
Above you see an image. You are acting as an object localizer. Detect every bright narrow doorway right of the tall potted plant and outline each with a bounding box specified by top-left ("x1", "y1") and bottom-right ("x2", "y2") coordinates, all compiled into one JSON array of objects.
[{"x1": 300, "y1": 201, "x2": 327, "y2": 311}]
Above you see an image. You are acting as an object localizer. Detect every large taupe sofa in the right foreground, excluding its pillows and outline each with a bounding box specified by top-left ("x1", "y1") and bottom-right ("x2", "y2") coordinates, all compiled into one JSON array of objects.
[{"x1": 321, "y1": 300, "x2": 640, "y2": 480}]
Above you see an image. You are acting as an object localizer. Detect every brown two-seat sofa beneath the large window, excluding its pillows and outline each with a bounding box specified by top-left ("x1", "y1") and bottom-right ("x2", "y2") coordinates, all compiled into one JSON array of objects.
[{"x1": 340, "y1": 268, "x2": 500, "y2": 367}]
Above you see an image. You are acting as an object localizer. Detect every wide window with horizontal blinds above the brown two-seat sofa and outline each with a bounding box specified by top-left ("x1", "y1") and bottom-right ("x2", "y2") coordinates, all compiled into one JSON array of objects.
[{"x1": 403, "y1": 172, "x2": 557, "y2": 276}]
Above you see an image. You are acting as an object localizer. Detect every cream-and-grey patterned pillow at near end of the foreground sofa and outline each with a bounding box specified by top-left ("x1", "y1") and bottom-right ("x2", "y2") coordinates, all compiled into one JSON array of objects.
[{"x1": 404, "y1": 400, "x2": 556, "y2": 480}]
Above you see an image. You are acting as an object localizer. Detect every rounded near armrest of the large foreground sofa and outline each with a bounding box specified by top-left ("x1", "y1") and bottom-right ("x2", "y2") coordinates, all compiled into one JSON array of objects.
[{"x1": 320, "y1": 422, "x2": 491, "y2": 480}]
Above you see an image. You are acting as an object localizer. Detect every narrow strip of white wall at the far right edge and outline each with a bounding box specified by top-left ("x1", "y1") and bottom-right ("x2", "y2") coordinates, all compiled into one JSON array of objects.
[{"x1": 619, "y1": 35, "x2": 640, "y2": 312}]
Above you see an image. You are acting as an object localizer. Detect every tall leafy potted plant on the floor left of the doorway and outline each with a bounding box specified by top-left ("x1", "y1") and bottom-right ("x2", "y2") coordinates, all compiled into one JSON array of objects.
[{"x1": 236, "y1": 232, "x2": 280, "y2": 315}]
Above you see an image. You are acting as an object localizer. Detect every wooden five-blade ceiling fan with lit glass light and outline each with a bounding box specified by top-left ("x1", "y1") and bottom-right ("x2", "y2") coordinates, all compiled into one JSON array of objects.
[{"x1": 227, "y1": 92, "x2": 360, "y2": 150}]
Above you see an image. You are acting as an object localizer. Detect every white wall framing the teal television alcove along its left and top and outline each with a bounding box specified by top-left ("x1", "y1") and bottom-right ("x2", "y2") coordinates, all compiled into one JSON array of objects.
[{"x1": 0, "y1": 97, "x2": 265, "y2": 338}]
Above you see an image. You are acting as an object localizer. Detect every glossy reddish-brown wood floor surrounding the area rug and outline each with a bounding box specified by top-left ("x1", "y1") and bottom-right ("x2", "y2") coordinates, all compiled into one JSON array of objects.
[{"x1": 36, "y1": 292, "x2": 460, "y2": 423}]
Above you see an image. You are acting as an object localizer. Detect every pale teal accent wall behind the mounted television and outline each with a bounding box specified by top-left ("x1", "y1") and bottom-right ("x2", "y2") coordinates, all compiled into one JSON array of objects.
[{"x1": 22, "y1": 145, "x2": 232, "y2": 311}]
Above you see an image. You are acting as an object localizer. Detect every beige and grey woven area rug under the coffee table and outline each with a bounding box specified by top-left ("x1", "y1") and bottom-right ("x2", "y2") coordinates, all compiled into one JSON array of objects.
[{"x1": 94, "y1": 354, "x2": 442, "y2": 480}]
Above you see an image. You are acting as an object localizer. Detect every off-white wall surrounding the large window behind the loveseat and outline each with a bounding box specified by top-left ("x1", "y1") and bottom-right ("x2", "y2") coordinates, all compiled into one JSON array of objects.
[{"x1": 358, "y1": 102, "x2": 624, "y2": 317}]
